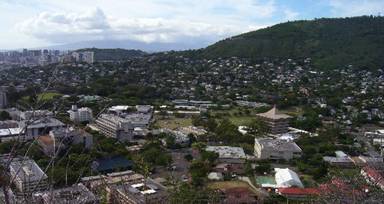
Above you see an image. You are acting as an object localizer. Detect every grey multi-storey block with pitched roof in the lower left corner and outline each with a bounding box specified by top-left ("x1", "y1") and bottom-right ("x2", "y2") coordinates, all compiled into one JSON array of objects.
[{"x1": 9, "y1": 158, "x2": 48, "y2": 194}]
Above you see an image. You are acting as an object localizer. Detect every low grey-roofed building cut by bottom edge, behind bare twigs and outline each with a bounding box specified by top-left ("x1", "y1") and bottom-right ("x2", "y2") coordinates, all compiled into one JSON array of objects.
[{"x1": 33, "y1": 183, "x2": 100, "y2": 204}]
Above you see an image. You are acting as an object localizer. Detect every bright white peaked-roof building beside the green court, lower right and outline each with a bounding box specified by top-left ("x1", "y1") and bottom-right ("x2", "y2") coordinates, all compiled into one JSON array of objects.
[{"x1": 275, "y1": 168, "x2": 304, "y2": 188}]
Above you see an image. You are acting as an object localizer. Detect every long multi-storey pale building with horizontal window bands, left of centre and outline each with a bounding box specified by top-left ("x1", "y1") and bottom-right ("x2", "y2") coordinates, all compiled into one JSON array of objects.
[{"x1": 96, "y1": 114, "x2": 134, "y2": 141}]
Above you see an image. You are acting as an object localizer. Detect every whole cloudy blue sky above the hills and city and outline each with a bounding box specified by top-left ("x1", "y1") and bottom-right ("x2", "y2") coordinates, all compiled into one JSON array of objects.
[{"x1": 0, "y1": 0, "x2": 384, "y2": 49}]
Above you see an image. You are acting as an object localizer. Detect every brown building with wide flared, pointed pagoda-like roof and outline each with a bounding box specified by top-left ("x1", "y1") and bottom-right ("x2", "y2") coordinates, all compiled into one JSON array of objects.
[{"x1": 257, "y1": 106, "x2": 291, "y2": 134}]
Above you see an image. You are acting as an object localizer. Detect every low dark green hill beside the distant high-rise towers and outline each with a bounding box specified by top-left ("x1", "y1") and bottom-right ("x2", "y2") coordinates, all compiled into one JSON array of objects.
[{"x1": 78, "y1": 48, "x2": 147, "y2": 61}]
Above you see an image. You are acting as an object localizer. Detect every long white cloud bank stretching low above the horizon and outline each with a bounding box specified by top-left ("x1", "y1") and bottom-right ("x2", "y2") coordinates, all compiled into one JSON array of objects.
[{"x1": 16, "y1": 8, "x2": 270, "y2": 43}]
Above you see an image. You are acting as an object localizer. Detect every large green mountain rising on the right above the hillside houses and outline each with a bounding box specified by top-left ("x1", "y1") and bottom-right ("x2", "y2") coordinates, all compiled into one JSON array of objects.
[{"x1": 200, "y1": 16, "x2": 384, "y2": 69}]
